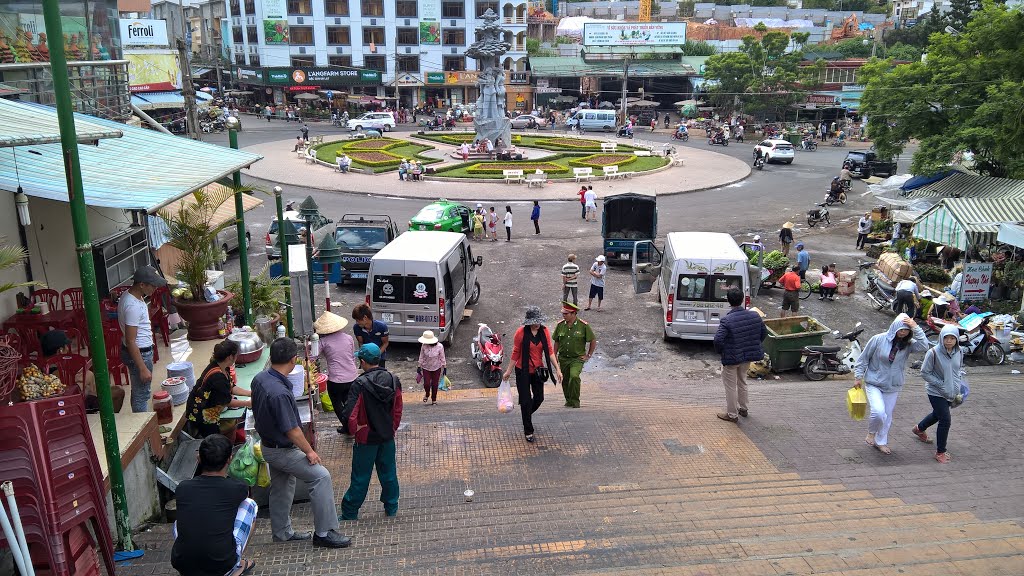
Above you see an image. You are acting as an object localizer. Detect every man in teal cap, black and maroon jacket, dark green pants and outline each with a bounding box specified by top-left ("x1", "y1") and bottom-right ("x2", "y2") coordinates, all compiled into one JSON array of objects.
[{"x1": 341, "y1": 343, "x2": 401, "y2": 520}]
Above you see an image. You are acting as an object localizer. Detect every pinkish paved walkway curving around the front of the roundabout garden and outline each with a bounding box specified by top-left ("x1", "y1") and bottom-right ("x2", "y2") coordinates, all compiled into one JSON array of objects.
[{"x1": 243, "y1": 136, "x2": 751, "y2": 200}]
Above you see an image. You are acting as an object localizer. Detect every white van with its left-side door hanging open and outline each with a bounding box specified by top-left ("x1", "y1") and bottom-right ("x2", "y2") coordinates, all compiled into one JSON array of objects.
[{"x1": 633, "y1": 232, "x2": 751, "y2": 340}]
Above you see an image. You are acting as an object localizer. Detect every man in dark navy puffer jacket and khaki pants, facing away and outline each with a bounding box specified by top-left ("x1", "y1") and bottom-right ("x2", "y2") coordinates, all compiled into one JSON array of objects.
[{"x1": 715, "y1": 287, "x2": 768, "y2": 422}]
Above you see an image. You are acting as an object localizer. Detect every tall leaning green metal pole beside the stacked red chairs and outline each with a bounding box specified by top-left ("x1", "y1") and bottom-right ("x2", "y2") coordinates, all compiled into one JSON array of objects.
[{"x1": 43, "y1": 0, "x2": 135, "y2": 550}]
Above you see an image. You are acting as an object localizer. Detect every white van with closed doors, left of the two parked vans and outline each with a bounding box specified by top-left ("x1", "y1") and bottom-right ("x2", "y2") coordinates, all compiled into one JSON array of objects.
[{"x1": 367, "y1": 232, "x2": 483, "y2": 343}]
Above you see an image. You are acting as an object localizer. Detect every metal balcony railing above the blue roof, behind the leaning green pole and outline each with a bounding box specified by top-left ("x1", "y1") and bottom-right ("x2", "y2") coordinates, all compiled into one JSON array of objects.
[{"x1": 0, "y1": 60, "x2": 131, "y2": 121}]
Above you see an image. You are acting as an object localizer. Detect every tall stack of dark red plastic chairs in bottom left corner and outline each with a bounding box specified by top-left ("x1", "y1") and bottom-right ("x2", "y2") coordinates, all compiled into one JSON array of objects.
[{"x1": 0, "y1": 395, "x2": 115, "y2": 576}]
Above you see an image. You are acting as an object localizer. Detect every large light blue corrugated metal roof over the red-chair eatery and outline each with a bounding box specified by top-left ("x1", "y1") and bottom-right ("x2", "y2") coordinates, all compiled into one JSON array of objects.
[{"x1": 0, "y1": 102, "x2": 263, "y2": 212}]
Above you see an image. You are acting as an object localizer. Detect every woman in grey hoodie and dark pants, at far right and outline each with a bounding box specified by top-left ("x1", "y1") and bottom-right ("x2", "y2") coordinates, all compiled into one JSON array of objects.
[{"x1": 911, "y1": 324, "x2": 964, "y2": 464}]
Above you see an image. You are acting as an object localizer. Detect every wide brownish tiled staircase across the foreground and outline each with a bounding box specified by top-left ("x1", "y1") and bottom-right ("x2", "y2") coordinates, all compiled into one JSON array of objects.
[{"x1": 125, "y1": 386, "x2": 1024, "y2": 576}]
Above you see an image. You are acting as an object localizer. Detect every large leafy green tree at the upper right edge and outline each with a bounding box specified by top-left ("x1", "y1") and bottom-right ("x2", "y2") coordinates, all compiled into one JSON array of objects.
[{"x1": 861, "y1": 0, "x2": 1024, "y2": 178}]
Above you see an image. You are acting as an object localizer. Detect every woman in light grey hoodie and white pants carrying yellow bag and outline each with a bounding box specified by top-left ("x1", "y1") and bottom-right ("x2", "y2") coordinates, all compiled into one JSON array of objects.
[{"x1": 853, "y1": 314, "x2": 928, "y2": 454}]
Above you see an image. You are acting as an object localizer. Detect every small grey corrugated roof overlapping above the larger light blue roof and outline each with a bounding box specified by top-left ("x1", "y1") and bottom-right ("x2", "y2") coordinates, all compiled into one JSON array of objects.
[{"x1": 0, "y1": 98, "x2": 121, "y2": 148}]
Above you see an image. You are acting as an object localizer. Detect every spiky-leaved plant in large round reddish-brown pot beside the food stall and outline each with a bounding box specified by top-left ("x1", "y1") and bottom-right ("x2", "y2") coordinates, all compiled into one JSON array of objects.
[{"x1": 161, "y1": 188, "x2": 234, "y2": 340}]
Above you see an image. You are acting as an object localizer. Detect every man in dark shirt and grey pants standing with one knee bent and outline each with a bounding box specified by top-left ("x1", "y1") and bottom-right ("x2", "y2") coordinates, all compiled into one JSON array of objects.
[{"x1": 252, "y1": 338, "x2": 352, "y2": 548}]
